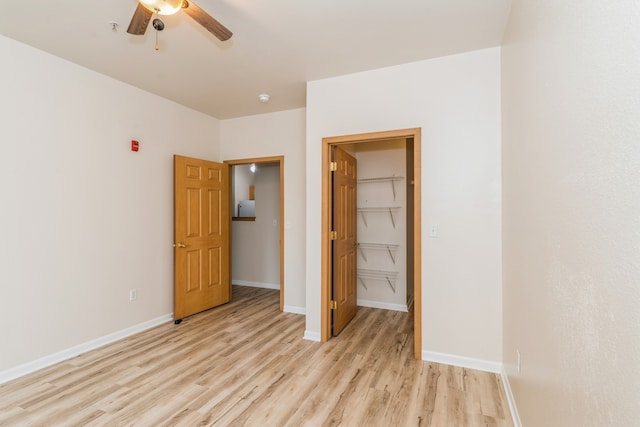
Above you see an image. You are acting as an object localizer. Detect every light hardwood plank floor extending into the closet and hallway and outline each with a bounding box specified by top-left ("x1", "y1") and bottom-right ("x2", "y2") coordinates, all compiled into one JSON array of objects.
[{"x1": 0, "y1": 286, "x2": 512, "y2": 427}]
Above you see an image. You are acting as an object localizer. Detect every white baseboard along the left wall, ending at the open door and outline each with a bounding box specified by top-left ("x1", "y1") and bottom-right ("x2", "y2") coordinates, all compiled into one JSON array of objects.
[{"x1": 0, "y1": 313, "x2": 173, "y2": 384}]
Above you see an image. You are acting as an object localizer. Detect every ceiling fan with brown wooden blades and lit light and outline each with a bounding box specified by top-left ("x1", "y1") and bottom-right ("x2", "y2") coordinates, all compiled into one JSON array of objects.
[{"x1": 127, "y1": 0, "x2": 233, "y2": 41}]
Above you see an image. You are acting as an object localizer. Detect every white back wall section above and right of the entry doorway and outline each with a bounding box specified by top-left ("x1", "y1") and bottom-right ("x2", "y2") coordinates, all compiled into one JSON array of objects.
[{"x1": 220, "y1": 109, "x2": 306, "y2": 312}]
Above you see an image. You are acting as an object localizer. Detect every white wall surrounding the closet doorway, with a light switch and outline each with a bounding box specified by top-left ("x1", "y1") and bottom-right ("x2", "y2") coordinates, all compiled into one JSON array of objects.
[{"x1": 306, "y1": 48, "x2": 502, "y2": 362}]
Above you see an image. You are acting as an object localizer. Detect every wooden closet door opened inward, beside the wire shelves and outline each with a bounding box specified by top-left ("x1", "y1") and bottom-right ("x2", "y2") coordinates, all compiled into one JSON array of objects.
[{"x1": 331, "y1": 146, "x2": 357, "y2": 336}]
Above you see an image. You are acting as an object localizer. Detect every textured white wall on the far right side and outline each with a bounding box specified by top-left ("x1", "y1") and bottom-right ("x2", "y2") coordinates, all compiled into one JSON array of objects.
[{"x1": 502, "y1": 0, "x2": 640, "y2": 426}]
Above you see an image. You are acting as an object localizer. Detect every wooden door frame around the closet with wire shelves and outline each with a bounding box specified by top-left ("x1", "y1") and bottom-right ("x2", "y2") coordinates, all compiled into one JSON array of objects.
[{"x1": 320, "y1": 128, "x2": 422, "y2": 359}]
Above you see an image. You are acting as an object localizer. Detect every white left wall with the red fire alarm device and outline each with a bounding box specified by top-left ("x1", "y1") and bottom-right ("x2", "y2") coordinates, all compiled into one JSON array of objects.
[{"x1": 0, "y1": 36, "x2": 219, "y2": 373}]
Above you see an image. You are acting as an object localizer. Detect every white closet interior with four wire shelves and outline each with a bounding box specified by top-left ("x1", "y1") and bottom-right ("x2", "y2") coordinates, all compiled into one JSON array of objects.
[{"x1": 343, "y1": 139, "x2": 413, "y2": 311}]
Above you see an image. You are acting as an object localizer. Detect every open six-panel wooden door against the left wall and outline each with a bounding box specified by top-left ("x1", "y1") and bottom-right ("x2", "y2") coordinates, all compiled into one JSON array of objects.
[{"x1": 173, "y1": 156, "x2": 231, "y2": 322}]
